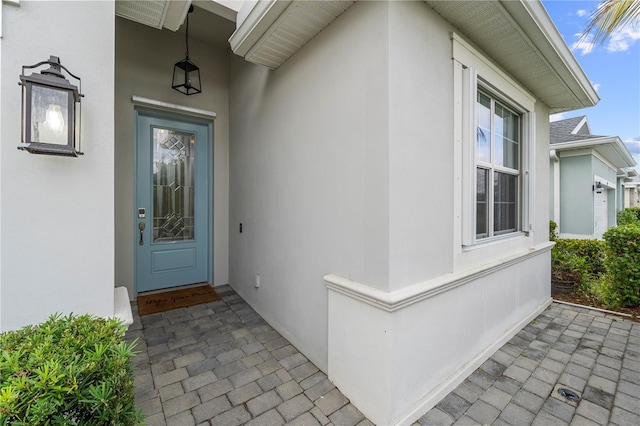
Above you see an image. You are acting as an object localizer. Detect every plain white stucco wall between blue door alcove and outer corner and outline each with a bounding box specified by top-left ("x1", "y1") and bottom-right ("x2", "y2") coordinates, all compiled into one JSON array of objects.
[{"x1": 230, "y1": 2, "x2": 389, "y2": 369}]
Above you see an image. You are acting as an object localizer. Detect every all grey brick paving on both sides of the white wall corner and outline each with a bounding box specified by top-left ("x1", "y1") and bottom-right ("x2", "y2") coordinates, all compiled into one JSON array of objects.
[{"x1": 127, "y1": 286, "x2": 640, "y2": 426}]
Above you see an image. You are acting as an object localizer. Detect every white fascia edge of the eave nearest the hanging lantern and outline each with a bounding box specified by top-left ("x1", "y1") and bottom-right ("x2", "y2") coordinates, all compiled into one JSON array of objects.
[{"x1": 229, "y1": 0, "x2": 291, "y2": 57}]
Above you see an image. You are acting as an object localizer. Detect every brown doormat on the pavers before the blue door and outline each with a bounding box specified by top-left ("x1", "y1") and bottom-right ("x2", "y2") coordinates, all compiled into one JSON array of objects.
[{"x1": 138, "y1": 284, "x2": 220, "y2": 316}]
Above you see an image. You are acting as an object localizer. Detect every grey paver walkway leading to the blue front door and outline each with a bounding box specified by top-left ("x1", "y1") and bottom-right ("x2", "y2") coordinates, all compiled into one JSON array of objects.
[{"x1": 126, "y1": 286, "x2": 372, "y2": 426}]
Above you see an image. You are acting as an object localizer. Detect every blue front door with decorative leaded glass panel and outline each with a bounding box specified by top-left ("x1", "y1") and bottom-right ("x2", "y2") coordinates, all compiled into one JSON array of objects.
[{"x1": 134, "y1": 110, "x2": 211, "y2": 293}]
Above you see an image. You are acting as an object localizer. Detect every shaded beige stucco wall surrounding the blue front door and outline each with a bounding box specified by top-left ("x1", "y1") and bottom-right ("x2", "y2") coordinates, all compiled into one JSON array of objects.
[{"x1": 115, "y1": 18, "x2": 229, "y2": 298}]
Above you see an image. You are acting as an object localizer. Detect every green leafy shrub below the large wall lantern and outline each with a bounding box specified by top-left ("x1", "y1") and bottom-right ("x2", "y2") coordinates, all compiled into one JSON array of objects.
[{"x1": 0, "y1": 315, "x2": 142, "y2": 425}]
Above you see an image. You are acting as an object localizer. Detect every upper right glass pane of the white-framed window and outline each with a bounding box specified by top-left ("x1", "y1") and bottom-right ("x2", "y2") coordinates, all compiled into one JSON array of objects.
[{"x1": 494, "y1": 102, "x2": 520, "y2": 170}]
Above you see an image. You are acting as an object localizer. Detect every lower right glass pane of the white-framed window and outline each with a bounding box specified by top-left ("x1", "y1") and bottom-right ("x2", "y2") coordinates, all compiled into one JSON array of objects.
[{"x1": 493, "y1": 172, "x2": 518, "y2": 235}]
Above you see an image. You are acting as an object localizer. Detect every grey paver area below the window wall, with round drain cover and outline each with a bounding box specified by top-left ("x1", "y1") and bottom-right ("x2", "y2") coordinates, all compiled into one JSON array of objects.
[{"x1": 418, "y1": 303, "x2": 640, "y2": 426}]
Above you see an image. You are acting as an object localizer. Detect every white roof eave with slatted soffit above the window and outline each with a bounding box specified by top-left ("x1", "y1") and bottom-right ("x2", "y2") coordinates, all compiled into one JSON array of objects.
[{"x1": 426, "y1": 0, "x2": 599, "y2": 112}]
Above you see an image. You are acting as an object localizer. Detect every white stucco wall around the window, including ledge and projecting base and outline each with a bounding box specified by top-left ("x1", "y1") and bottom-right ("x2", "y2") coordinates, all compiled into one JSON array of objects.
[{"x1": 327, "y1": 2, "x2": 550, "y2": 424}]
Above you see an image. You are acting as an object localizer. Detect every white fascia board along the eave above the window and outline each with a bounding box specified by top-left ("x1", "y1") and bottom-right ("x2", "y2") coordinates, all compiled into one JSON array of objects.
[{"x1": 500, "y1": 0, "x2": 600, "y2": 107}]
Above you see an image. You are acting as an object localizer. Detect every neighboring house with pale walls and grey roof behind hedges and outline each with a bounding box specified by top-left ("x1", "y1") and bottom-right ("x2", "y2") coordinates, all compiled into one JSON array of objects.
[{"x1": 549, "y1": 116, "x2": 636, "y2": 238}]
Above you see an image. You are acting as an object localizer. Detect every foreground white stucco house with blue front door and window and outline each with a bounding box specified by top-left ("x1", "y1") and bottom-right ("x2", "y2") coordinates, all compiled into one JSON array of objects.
[{"x1": 0, "y1": 0, "x2": 596, "y2": 424}]
